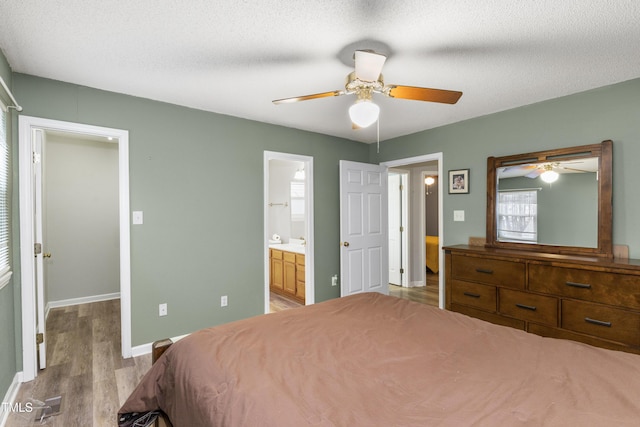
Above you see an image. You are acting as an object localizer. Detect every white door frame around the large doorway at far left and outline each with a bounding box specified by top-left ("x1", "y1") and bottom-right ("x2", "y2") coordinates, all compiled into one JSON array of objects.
[{"x1": 18, "y1": 115, "x2": 131, "y2": 382}]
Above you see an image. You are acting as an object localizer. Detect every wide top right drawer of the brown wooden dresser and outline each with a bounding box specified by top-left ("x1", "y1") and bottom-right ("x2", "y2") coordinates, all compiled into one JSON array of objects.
[{"x1": 529, "y1": 264, "x2": 640, "y2": 309}]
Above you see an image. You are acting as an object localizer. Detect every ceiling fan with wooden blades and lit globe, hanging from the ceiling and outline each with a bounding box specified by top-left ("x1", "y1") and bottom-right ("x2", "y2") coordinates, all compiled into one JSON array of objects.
[{"x1": 273, "y1": 50, "x2": 462, "y2": 129}]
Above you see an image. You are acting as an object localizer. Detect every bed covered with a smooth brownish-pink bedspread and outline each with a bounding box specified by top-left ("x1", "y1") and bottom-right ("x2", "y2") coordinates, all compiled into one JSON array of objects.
[{"x1": 120, "y1": 293, "x2": 640, "y2": 427}]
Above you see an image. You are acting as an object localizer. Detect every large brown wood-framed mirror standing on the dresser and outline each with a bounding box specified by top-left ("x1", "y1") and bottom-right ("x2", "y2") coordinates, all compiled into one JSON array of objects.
[{"x1": 486, "y1": 140, "x2": 613, "y2": 258}]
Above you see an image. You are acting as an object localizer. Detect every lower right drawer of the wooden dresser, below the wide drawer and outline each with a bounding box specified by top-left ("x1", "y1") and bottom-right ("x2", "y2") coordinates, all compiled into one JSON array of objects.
[{"x1": 561, "y1": 300, "x2": 640, "y2": 346}]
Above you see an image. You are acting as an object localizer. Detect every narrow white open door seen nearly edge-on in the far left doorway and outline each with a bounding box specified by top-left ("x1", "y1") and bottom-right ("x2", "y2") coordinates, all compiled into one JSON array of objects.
[{"x1": 33, "y1": 129, "x2": 47, "y2": 369}]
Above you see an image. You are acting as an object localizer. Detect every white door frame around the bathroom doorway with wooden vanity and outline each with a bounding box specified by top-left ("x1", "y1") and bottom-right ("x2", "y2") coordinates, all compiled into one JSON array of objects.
[{"x1": 263, "y1": 151, "x2": 316, "y2": 313}]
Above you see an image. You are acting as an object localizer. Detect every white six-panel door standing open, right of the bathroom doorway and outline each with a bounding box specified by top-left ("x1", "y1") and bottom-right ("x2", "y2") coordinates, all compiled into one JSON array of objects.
[{"x1": 340, "y1": 160, "x2": 389, "y2": 296}]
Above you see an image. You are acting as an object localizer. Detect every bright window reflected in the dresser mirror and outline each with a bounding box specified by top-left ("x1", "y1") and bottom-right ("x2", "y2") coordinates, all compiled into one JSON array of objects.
[{"x1": 498, "y1": 190, "x2": 538, "y2": 243}]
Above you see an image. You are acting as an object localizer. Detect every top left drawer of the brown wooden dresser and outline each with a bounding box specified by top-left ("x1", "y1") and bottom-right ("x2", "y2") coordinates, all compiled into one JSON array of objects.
[{"x1": 451, "y1": 255, "x2": 525, "y2": 289}]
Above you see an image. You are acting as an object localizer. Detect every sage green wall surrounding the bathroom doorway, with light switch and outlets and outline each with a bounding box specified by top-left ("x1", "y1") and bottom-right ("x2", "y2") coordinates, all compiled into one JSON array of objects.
[{"x1": 13, "y1": 74, "x2": 369, "y2": 346}]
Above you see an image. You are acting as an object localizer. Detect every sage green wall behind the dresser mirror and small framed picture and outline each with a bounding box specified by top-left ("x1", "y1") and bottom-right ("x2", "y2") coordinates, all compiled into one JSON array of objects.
[{"x1": 369, "y1": 79, "x2": 640, "y2": 258}]
